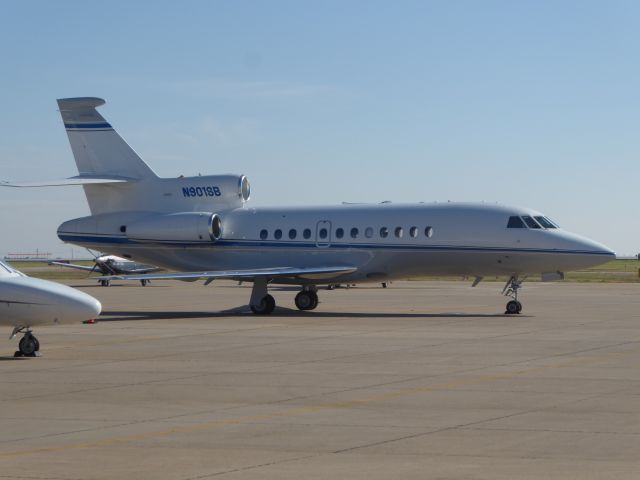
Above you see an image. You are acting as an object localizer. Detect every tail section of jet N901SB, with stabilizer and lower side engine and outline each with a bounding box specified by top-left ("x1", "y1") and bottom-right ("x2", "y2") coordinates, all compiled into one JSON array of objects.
[{"x1": 0, "y1": 97, "x2": 250, "y2": 246}]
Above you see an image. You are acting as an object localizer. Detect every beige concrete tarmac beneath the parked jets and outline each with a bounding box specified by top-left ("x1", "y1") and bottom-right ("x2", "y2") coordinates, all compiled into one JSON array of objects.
[{"x1": 0, "y1": 282, "x2": 640, "y2": 480}]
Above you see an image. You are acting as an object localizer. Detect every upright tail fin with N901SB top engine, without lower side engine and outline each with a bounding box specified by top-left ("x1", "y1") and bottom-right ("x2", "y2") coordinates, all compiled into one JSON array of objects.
[{"x1": 52, "y1": 97, "x2": 249, "y2": 215}]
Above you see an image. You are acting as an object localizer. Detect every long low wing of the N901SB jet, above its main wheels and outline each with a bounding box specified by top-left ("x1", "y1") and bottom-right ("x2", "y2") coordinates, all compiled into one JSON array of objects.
[{"x1": 101, "y1": 266, "x2": 357, "y2": 281}]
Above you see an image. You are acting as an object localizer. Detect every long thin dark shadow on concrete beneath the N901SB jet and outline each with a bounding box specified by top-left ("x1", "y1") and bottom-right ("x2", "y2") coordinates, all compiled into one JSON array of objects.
[{"x1": 98, "y1": 306, "x2": 516, "y2": 322}]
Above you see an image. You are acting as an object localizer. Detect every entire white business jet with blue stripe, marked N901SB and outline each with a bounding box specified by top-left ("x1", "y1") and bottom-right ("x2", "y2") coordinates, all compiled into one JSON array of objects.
[{"x1": 5, "y1": 98, "x2": 615, "y2": 314}]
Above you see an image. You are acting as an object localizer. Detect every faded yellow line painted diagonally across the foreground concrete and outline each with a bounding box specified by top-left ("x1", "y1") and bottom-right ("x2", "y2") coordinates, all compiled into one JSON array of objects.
[{"x1": 0, "y1": 339, "x2": 640, "y2": 458}]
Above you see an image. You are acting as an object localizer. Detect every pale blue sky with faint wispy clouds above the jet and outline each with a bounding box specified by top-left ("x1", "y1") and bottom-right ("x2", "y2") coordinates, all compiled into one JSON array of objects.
[{"x1": 0, "y1": 0, "x2": 640, "y2": 255}]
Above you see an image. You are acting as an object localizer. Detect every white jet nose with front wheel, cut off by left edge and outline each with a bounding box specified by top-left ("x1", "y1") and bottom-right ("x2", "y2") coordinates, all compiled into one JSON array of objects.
[{"x1": 0, "y1": 262, "x2": 102, "y2": 357}]
